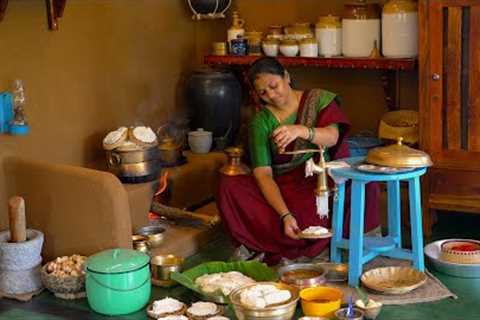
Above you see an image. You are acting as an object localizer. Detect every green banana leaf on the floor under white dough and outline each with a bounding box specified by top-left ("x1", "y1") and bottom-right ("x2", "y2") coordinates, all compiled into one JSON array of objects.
[{"x1": 170, "y1": 261, "x2": 278, "y2": 295}]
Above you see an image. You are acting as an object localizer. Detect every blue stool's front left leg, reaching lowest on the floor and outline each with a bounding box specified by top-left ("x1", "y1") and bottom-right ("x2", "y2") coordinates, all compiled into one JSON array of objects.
[{"x1": 348, "y1": 180, "x2": 365, "y2": 287}]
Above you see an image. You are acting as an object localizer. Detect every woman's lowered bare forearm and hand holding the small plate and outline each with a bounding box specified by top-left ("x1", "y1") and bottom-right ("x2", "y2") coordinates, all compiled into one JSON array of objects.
[{"x1": 253, "y1": 167, "x2": 300, "y2": 239}]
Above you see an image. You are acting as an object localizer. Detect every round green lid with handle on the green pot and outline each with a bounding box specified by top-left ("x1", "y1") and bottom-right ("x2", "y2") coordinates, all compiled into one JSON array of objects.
[{"x1": 87, "y1": 249, "x2": 150, "y2": 273}]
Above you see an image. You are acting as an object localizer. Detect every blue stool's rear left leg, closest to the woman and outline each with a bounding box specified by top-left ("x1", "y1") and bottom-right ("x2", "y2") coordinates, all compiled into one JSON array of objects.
[{"x1": 330, "y1": 183, "x2": 345, "y2": 263}]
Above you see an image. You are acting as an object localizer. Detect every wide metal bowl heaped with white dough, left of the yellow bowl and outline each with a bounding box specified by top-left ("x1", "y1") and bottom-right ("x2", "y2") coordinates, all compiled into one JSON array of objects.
[{"x1": 229, "y1": 282, "x2": 299, "y2": 320}]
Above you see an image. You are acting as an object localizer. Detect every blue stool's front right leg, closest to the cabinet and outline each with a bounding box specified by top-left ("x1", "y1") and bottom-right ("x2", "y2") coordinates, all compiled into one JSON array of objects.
[{"x1": 408, "y1": 177, "x2": 425, "y2": 272}]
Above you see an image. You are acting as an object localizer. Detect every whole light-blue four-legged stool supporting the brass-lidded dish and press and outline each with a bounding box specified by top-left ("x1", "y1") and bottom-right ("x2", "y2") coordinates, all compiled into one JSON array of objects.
[{"x1": 330, "y1": 157, "x2": 427, "y2": 287}]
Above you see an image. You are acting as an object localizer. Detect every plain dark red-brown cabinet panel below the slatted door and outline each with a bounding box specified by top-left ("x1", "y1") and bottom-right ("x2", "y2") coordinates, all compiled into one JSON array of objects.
[{"x1": 428, "y1": 168, "x2": 480, "y2": 200}]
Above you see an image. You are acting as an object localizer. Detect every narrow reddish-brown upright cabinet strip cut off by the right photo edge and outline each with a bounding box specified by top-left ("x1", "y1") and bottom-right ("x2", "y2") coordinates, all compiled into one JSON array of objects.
[{"x1": 468, "y1": 2, "x2": 480, "y2": 151}]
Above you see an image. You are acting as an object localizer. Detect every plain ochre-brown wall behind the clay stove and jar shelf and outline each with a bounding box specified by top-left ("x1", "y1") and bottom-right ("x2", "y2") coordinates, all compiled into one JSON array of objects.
[{"x1": 0, "y1": 0, "x2": 417, "y2": 229}]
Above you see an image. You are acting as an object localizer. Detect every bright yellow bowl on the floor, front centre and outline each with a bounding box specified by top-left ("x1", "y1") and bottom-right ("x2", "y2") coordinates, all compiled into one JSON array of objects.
[{"x1": 300, "y1": 287, "x2": 343, "y2": 317}]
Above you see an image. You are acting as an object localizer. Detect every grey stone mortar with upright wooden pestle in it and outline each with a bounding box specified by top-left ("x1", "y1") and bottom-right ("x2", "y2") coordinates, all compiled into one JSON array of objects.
[{"x1": 0, "y1": 196, "x2": 44, "y2": 295}]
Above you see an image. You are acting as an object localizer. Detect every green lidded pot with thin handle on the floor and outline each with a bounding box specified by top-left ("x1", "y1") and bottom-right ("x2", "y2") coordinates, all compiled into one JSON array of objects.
[{"x1": 85, "y1": 249, "x2": 151, "y2": 316}]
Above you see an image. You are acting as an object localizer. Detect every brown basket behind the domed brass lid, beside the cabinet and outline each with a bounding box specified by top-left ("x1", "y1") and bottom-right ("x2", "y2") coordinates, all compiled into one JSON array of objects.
[{"x1": 378, "y1": 110, "x2": 418, "y2": 144}]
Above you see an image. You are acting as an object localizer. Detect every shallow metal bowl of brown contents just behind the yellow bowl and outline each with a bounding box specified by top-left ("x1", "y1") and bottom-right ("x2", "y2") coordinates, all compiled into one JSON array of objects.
[{"x1": 277, "y1": 263, "x2": 326, "y2": 289}]
